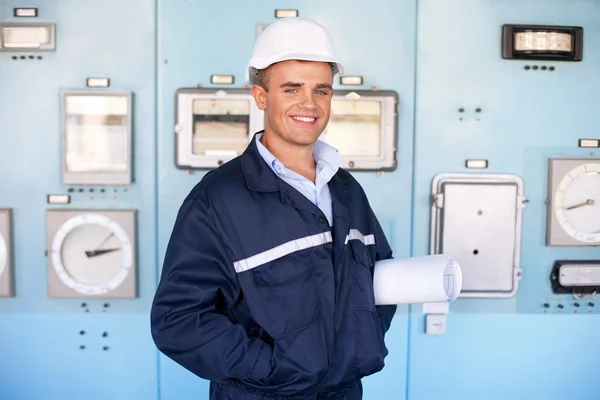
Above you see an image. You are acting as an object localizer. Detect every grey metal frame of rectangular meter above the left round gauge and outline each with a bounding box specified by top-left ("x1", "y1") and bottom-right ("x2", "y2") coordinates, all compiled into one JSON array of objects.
[{"x1": 60, "y1": 90, "x2": 133, "y2": 186}]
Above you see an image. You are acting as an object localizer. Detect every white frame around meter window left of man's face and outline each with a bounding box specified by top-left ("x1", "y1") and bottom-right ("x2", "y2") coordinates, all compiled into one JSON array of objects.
[{"x1": 174, "y1": 88, "x2": 264, "y2": 169}]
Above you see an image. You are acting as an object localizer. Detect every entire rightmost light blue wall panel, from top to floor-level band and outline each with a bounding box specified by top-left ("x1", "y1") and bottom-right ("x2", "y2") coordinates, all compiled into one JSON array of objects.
[{"x1": 408, "y1": 0, "x2": 600, "y2": 400}]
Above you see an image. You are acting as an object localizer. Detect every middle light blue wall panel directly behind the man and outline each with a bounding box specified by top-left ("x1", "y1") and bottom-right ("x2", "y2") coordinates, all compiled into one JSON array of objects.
[{"x1": 158, "y1": 0, "x2": 415, "y2": 399}]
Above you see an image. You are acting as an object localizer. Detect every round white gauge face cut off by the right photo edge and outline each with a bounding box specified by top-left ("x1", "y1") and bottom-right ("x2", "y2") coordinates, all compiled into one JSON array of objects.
[{"x1": 554, "y1": 163, "x2": 600, "y2": 244}]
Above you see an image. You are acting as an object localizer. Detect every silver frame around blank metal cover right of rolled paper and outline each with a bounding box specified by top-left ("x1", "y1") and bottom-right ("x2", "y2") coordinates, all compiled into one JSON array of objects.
[{"x1": 429, "y1": 173, "x2": 526, "y2": 298}]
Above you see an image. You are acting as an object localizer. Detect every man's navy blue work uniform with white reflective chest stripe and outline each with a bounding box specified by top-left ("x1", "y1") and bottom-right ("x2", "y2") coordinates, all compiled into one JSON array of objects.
[{"x1": 151, "y1": 130, "x2": 396, "y2": 400}]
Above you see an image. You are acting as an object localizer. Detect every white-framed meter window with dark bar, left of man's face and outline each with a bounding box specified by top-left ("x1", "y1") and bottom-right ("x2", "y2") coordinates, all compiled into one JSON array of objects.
[{"x1": 175, "y1": 88, "x2": 264, "y2": 169}]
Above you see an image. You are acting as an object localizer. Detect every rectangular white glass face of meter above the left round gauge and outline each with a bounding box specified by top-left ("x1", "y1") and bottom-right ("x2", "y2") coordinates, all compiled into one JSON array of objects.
[{"x1": 65, "y1": 95, "x2": 129, "y2": 172}]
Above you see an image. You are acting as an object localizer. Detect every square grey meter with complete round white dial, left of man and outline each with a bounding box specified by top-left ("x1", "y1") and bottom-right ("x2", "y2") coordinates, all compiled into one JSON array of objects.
[{"x1": 46, "y1": 209, "x2": 137, "y2": 298}]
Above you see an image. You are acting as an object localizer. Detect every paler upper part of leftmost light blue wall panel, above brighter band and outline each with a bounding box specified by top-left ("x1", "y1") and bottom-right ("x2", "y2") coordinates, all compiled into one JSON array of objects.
[{"x1": 0, "y1": 0, "x2": 156, "y2": 312}]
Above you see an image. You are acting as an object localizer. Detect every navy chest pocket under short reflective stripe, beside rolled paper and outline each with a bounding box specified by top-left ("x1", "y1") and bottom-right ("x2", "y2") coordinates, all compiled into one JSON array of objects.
[{"x1": 348, "y1": 240, "x2": 375, "y2": 310}]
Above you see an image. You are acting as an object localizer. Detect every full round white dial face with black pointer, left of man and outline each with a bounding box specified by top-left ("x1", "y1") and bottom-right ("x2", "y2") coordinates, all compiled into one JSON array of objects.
[{"x1": 52, "y1": 214, "x2": 133, "y2": 295}]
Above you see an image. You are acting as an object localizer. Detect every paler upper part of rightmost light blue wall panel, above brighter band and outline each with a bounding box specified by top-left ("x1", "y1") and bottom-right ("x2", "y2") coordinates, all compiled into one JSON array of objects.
[{"x1": 414, "y1": 0, "x2": 600, "y2": 313}]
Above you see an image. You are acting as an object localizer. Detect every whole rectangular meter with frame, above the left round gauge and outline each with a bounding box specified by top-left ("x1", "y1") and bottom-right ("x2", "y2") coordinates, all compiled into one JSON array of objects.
[{"x1": 62, "y1": 91, "x2": 132, "y2": 185}]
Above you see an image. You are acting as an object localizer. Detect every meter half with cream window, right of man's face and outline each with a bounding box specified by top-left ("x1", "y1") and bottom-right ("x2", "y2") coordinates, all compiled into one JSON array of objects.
[{"x1": 320, "y1": 90, "x2": 398, "y2": 170}]
